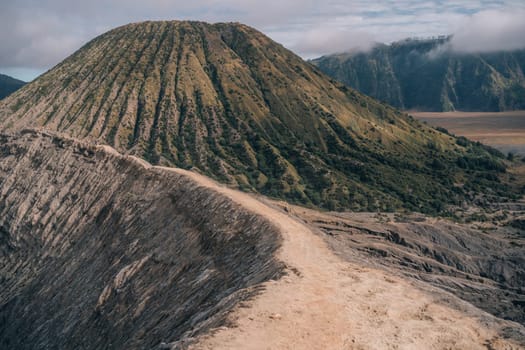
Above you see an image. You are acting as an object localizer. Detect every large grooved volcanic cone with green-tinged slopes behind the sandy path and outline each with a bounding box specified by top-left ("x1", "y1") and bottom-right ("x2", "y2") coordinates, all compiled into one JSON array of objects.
[{"x1": 0, "y1": 21, "x2": 510, "y2": 213}]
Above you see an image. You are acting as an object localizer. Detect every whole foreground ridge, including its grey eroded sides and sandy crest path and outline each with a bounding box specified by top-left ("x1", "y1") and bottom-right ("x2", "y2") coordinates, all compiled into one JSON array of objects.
[{"x1": 0, "y1": 130, "x2": 525, "y2": 350}]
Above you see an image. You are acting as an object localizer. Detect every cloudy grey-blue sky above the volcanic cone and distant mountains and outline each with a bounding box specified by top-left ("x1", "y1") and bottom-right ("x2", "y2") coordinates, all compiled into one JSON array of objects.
[{"x1": 0, "y1": 0, "x2": 525, "y2": 80}]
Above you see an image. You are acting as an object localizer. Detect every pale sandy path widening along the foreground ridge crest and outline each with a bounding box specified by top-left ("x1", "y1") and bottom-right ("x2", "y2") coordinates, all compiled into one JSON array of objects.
[{"x1": 152, "y1": 168, "x2": 521, "y2": 349}]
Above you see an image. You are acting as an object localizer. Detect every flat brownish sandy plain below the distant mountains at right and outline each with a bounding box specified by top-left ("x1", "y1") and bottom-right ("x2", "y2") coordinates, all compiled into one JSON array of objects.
[{"x1": 408, "y1": 111, "x2": 525, "y2": 156}]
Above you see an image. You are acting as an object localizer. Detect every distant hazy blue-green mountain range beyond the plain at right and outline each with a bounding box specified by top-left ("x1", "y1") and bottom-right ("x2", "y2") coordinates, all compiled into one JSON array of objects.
[{"x1": 311, "y1": 37, "x2": 525, "y2": 111}]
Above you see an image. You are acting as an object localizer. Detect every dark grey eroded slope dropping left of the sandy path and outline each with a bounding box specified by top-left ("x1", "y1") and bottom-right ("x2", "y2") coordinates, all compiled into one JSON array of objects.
[{"x1": 0, "y1": 131, "x2": 282, "y2": 349}]
